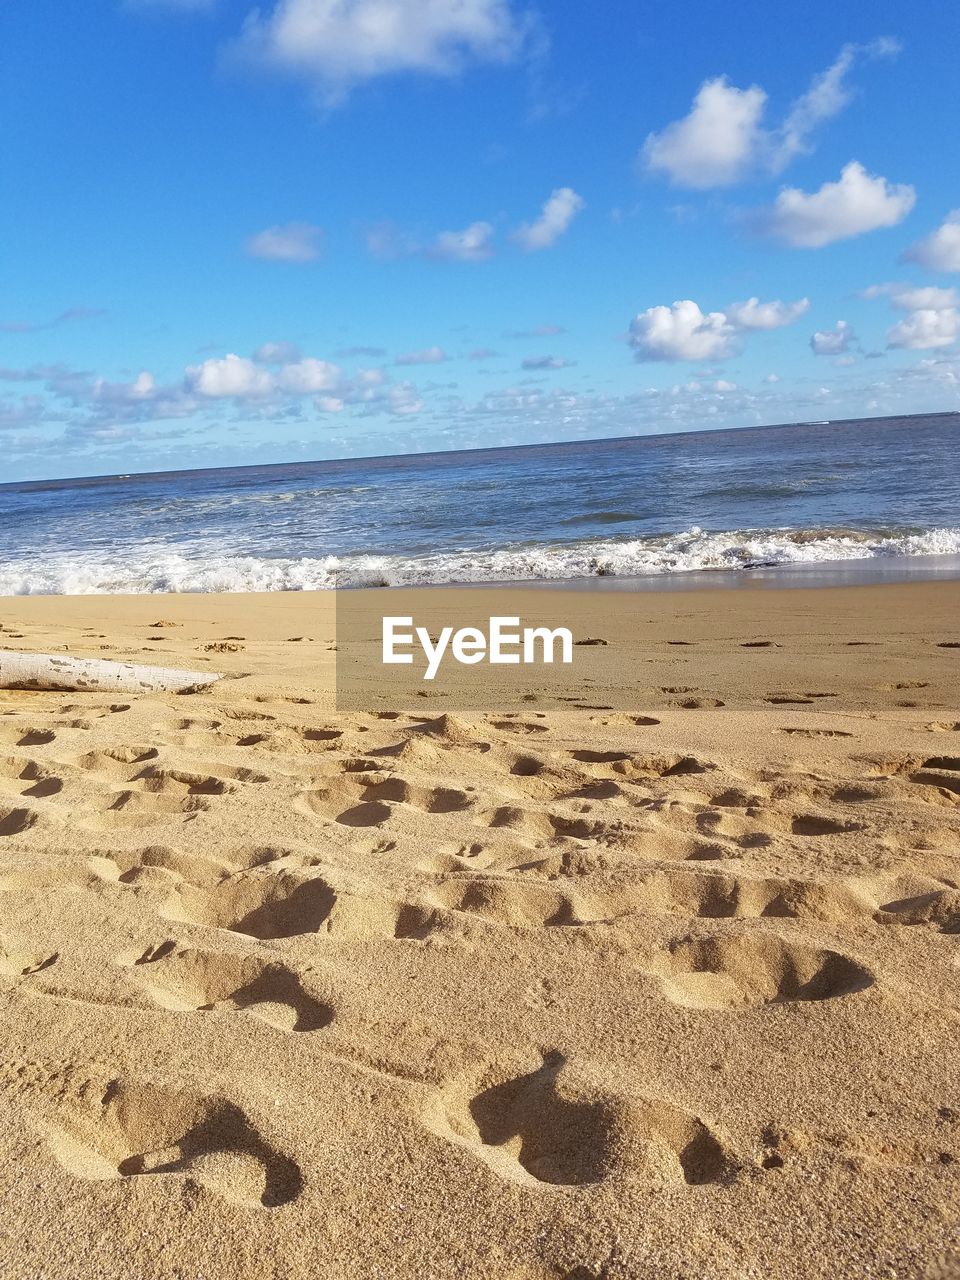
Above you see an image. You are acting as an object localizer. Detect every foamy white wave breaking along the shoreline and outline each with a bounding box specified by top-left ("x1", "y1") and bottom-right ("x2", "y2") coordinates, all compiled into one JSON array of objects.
[{"x1": 0, "y1": 527, "x2": 960, "y2": 595}]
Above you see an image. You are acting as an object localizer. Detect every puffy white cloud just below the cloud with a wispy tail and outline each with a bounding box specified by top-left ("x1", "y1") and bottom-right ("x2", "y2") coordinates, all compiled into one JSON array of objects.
[{"x1": 751, "y1": 160, "x2": 916, "y2": 248}]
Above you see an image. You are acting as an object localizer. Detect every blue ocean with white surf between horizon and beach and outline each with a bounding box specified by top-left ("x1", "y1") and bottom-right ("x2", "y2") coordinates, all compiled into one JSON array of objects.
[{"x1": 0, "y1": 415, "x2": 960, "y2": 595}]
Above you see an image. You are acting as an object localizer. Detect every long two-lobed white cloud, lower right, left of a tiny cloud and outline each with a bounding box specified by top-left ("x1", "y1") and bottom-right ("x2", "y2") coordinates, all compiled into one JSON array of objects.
[{"x1": 628, "y1": 298, "x2": 810, "y2": 360}]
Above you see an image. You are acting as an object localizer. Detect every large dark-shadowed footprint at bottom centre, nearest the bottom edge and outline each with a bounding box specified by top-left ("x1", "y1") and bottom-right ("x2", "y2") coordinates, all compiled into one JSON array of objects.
[{"x1": 422, "y1": 1052, "x2": 735, "y2": 1189}]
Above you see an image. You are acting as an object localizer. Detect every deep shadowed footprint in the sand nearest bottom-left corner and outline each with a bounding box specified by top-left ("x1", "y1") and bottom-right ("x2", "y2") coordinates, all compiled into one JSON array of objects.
[{"x1": 36, "y1": 1080, "x2": 303, "y2": 1208}]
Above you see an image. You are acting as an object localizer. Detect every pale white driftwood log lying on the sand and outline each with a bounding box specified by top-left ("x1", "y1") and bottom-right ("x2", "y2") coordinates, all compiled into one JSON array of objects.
[{"x1": 0, "y1": 650, "x2": 221, "y2": 694}]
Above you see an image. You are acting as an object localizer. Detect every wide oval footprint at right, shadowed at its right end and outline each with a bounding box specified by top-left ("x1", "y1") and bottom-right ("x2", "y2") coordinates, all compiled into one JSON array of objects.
[{"x1": 648, "y1": 932, "x2": 873, "y2": 1010}]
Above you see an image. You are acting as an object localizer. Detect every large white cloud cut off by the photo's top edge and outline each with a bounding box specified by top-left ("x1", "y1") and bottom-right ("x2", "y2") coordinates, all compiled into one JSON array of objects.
[{"x1": 236, "y1": 0, "x2": 526, "y2": 102}]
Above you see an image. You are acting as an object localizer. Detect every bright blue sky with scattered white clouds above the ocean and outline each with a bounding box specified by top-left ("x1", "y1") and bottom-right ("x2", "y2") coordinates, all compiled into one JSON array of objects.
[{"x1": 0, "y1": 0, "x2": 960, "y2": 481}]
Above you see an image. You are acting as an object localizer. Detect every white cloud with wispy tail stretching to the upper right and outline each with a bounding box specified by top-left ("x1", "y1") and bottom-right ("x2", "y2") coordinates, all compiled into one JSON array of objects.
[{"x1": 641, "y1": 38, "x2": 899, "y2": 189}]
